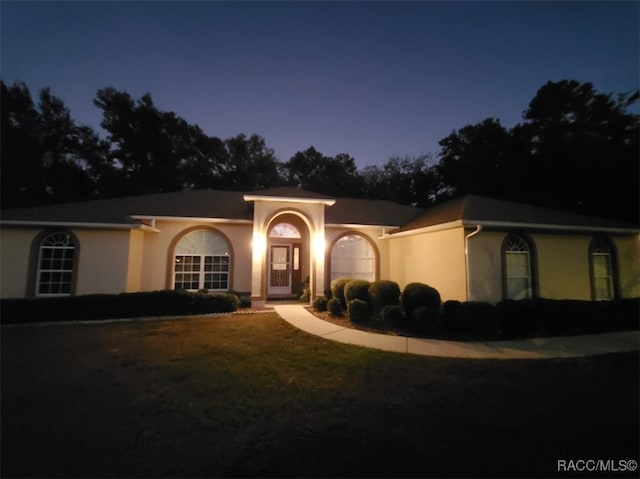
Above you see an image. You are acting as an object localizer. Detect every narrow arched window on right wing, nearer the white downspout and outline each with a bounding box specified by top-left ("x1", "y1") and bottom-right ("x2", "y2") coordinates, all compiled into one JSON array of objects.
[{"x1": 503, "y1": 235, "x2": 535, "y2": 299}]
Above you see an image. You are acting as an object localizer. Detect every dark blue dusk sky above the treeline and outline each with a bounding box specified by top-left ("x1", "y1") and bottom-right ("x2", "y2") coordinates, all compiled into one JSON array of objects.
[{"x1": 0, "y1": 1, "x2": 640, "y2": 166}]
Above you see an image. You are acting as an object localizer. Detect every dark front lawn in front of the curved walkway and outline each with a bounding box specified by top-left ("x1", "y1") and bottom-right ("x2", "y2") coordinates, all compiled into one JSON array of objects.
[{"x1": 1, "y1": 313, "x2": 640, "y2": 477}]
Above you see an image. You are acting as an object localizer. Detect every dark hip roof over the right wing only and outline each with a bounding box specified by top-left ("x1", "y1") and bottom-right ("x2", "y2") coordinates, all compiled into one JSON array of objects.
[{"x1": 394, "y1": 195, "x2": 638, "y2": 233}]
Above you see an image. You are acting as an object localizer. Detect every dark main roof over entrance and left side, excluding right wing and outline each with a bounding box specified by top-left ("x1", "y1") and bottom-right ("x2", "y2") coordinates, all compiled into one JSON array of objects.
[{"x1": 0, "y1": 187, "x2": 424, "y2": 227}]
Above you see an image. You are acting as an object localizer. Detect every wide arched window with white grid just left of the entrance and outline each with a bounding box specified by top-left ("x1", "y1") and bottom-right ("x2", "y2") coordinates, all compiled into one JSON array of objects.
[{"x1": 173, "y1": 230, "x2": 231, "y2": 291}]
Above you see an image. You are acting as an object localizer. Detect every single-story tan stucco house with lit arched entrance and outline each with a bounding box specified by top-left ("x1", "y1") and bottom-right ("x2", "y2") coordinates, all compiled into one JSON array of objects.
[{"x1": 0, "y1": 187, "x2": 640, "y2": 306}]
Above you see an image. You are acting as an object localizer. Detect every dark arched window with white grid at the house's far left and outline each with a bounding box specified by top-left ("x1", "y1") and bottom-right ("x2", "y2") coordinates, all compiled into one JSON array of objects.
[{"x1": 36, "y1": 232, "x2": 77, "y2": 296}]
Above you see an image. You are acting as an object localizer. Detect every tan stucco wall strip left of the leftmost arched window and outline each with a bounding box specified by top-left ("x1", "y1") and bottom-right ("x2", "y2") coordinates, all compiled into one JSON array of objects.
[{"x1": 0, "y1": 228, "x2": 40, "y2": 298}]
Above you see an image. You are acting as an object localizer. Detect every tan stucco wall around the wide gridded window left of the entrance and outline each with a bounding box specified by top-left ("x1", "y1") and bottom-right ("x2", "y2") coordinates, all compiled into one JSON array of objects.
[{"x1": 140, "y1": 220, "x2": 252, "y2": 292}]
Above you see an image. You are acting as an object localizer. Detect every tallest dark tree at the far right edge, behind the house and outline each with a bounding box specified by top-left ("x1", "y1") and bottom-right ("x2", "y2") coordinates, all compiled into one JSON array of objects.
[{"x1": 513, "y1": 80, "x2": 640, "y2": 222}]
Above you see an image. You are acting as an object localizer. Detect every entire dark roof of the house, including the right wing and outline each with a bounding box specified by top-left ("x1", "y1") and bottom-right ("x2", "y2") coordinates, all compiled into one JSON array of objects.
[{"x1": 0, "y1": 193, "x2": 638, "y2": 235}]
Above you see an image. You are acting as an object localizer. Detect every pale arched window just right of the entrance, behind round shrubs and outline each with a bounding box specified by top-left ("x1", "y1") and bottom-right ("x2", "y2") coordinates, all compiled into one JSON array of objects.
[{"x1": 331, "y1": 234, "x2": 376, "y2": 281}]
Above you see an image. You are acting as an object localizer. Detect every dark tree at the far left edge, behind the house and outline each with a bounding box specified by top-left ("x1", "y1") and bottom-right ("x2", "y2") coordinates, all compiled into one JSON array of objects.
[{"x1": 1, "y1": 82, "x2": 105, "y2": 208}]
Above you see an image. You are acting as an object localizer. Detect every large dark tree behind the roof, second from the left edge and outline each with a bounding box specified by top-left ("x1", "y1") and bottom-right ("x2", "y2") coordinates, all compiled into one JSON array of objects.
[{"x1": 94, "y1": 88, "x2": 232, "y2": 196}]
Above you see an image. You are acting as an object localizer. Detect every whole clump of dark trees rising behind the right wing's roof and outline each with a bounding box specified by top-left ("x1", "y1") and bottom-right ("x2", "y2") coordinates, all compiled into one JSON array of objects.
[{"x1": 437, "y1": 80, "x2": 640, "y2": 222}]
